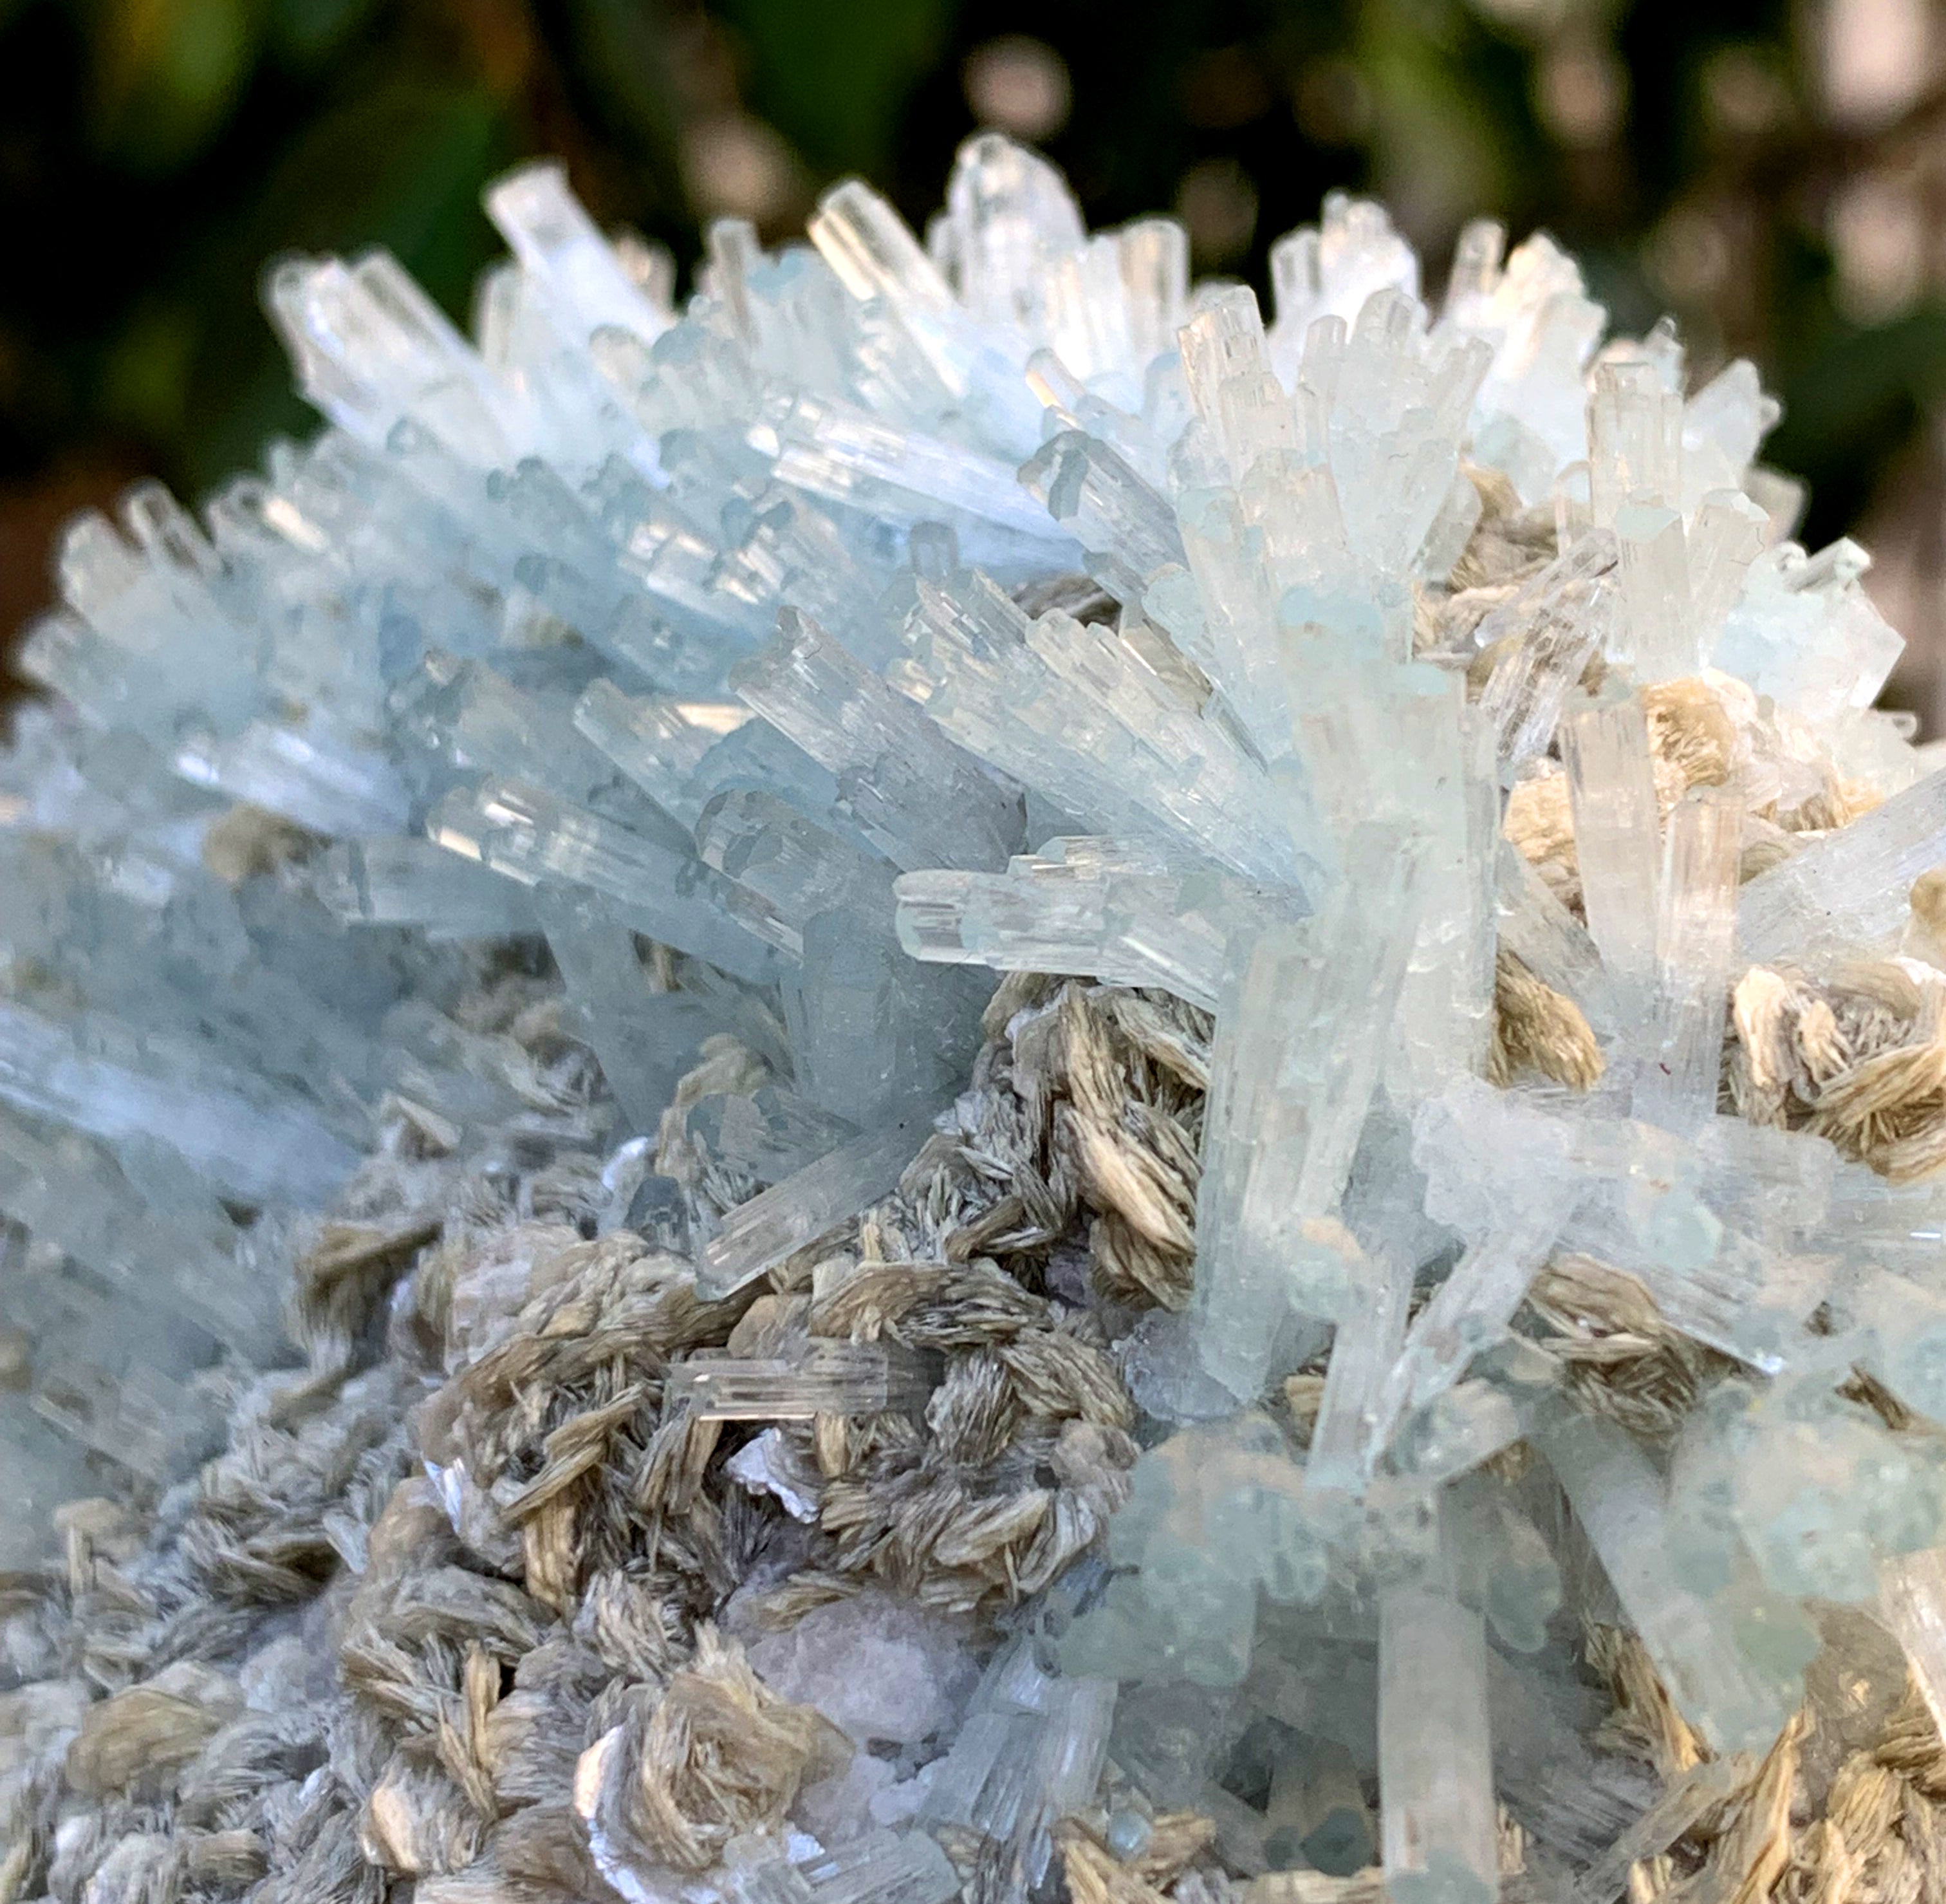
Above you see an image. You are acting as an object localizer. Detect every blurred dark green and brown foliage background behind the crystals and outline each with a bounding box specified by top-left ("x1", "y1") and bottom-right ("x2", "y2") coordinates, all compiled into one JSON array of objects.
[{"x1": 0, "y1": 0, "x2": 1946, "y2": 734}]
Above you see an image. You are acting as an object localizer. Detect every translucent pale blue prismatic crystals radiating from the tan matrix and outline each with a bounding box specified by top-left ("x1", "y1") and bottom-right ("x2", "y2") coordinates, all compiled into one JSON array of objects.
[{"x1": 0, "y1": 136, "x2": 1946, "y2": 1904}]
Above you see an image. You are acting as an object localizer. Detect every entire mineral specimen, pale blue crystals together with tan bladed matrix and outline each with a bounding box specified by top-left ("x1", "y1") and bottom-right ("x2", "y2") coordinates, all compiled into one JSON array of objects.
[{"x1": 0, "y1": 136, "x2": 1946, "y2": 1904}]
